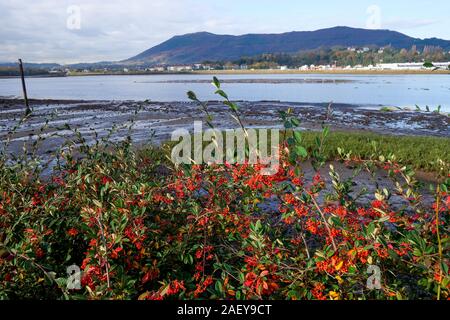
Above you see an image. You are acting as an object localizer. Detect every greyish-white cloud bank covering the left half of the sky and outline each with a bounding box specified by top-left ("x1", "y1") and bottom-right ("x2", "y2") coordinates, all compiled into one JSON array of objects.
[{"x1": 0, "y1": 0, "x2": 243, "y2": 62}]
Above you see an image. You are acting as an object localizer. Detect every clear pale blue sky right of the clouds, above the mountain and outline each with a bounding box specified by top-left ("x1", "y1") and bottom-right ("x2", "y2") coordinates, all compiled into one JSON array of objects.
[{"x1": 225, "y1": 0, "x2": 450, "y2": 39}]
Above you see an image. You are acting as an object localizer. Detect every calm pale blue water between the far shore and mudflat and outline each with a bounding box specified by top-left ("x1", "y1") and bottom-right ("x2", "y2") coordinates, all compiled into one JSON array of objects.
[{"x1": 0, "y1": 74, "x2": 450, "y2": 112}]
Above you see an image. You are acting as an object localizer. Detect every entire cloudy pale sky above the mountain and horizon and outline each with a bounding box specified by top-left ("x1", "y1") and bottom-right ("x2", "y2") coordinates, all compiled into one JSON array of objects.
[{"x1": 0, "y1": 0, "x2": 450, "y2": 63}]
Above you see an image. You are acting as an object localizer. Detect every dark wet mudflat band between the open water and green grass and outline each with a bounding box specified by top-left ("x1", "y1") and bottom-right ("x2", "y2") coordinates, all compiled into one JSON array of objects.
[{"x1": 0, "y1": 97, "x2": 450, "y2": 140}]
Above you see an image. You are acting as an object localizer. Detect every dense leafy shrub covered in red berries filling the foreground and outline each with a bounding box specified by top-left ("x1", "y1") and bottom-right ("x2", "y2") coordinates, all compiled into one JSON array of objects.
[{"x1": 0, "y1": 79, "x2": 450, "y2": 300}]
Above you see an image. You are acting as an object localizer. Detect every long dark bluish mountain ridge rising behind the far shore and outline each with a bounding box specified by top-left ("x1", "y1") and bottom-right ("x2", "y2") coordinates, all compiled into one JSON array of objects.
[{"x1": 124, "y1": 27, "x2": 450, "y2": 64}]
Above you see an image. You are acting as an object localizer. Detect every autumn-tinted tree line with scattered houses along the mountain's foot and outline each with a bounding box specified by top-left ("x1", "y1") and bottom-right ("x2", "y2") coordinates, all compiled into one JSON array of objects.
[{"x1": 203, "y1": 46, "x2": 450, "y2": 69}]
